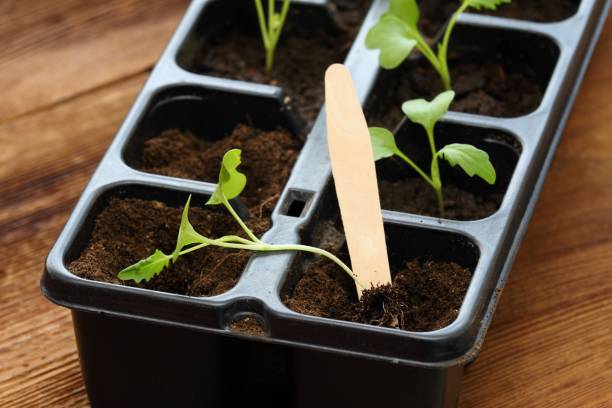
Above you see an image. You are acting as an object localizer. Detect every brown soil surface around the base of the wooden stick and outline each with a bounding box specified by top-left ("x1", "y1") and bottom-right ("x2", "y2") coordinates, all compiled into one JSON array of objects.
[{"x1": 284, "y1": 223, "x2": 472, "y2": 331}]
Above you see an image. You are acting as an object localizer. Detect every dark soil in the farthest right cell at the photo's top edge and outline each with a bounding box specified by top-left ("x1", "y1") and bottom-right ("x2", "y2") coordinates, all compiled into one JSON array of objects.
[{"x1": 419, "y1": 0, "x2": 579, "y2": 37}]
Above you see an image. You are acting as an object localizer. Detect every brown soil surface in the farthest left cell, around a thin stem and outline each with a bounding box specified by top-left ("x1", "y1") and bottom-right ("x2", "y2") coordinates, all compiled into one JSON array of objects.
[{"x1": 185, "y1": 0, "x2": 371, "y2": 128}]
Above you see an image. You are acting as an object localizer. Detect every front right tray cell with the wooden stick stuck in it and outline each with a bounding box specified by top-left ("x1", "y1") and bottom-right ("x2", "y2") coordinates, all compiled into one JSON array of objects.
[{"x1": 280, "y1": 182, "x2": 480, "y2": 331}]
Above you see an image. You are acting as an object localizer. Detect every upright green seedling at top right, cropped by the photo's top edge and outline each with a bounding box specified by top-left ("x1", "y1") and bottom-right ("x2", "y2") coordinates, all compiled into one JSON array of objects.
[{"x1": 366, "y1": 0, "x2": 511, "y2": 90}]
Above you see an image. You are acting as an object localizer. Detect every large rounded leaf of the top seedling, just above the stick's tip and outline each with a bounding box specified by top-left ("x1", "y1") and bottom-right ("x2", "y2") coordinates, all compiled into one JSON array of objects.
[{"x1": 366, "y1": 14, "x2": 417, "y2": 69}]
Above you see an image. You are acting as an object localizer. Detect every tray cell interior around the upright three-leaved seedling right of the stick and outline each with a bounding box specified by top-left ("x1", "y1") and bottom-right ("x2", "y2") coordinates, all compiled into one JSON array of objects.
[{"x1": 376, "y1": 121, "x2": 521, "y2": 220}]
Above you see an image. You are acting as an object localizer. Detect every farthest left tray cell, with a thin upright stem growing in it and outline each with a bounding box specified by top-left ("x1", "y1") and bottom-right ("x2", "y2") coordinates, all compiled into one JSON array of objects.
[{"x1": 178, "y1": 0, "x2": 371, "y2": 127}]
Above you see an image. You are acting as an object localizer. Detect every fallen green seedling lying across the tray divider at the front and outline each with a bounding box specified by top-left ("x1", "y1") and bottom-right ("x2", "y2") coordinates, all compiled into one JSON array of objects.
[{"x1": 118, "y1": 149, "x2": 363, "y2": 288}]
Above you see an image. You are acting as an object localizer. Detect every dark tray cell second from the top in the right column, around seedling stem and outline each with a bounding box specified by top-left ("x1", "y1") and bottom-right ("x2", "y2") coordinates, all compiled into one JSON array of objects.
[{"x1": 366, "y1": 25, "x2": 559, "y2": 121}]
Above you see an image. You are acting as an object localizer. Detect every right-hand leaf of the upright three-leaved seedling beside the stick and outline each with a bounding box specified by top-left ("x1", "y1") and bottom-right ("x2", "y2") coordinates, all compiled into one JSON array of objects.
[{"x1": 438, "y1": 143, "x2": 496, "y2": 184}]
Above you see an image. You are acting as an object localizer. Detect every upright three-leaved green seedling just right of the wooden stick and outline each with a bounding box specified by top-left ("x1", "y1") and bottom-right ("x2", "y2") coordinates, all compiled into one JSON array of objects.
[{"x1": 370, "y1": 91, "x2": 496, "y2": 217}]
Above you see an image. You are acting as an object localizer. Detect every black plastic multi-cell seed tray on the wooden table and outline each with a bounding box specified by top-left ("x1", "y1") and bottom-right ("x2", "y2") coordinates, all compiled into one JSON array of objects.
[{"x1": 41, "y1": 0, "x2": 610, "y2": 407}]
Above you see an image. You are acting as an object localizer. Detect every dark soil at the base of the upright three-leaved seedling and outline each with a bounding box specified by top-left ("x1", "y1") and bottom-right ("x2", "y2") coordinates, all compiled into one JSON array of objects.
[{"x1": 379, "y1": 177, "x2": 503, "y2": 221}]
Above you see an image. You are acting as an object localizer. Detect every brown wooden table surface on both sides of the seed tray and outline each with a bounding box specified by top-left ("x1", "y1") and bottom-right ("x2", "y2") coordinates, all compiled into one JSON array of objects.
[{"x1": 0, "y1": 0, "x2": 612, "y2": 408}]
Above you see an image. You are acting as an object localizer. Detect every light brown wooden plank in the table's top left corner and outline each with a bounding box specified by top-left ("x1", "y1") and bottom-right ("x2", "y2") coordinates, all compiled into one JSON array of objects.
[{"x1": 0, "y1": 0, "x2": 188, "y2": 123}]
